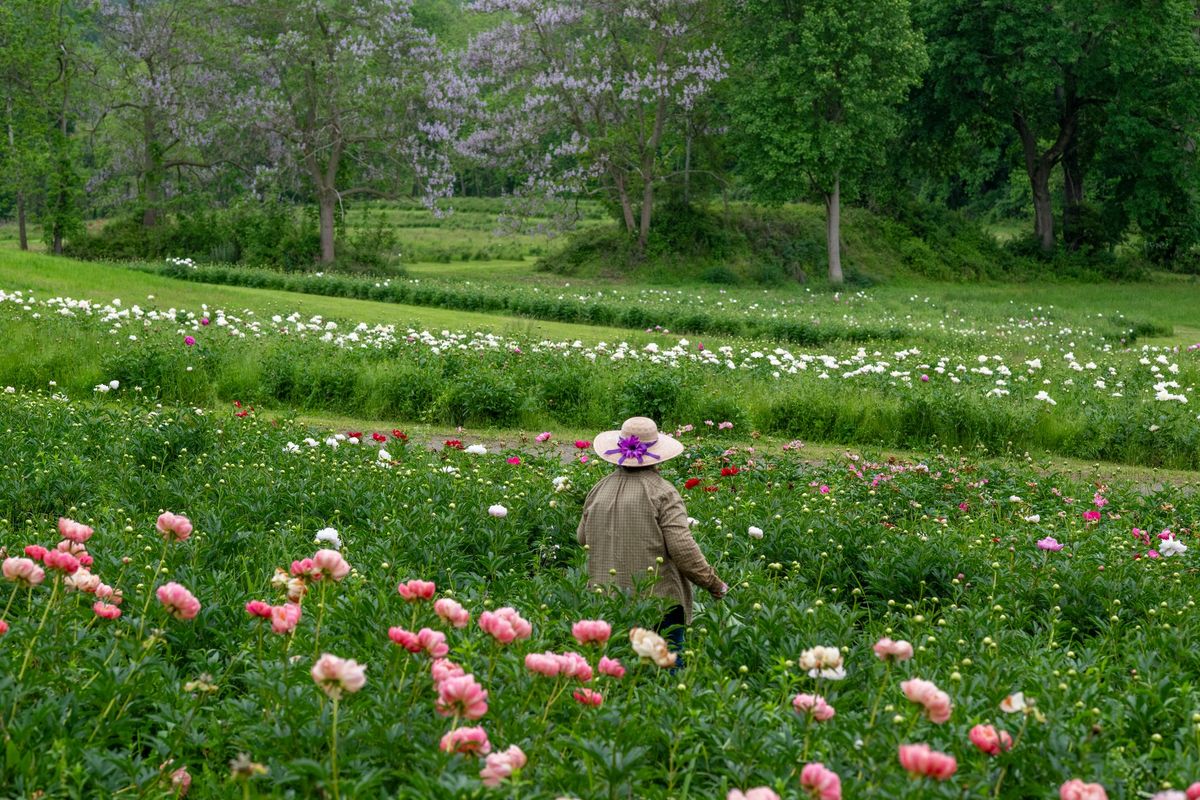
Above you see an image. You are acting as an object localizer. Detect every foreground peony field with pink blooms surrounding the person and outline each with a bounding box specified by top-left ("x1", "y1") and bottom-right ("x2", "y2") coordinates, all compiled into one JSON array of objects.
[{"x1": 0, "y1": 392, "x2": 1200, "y2": 800}]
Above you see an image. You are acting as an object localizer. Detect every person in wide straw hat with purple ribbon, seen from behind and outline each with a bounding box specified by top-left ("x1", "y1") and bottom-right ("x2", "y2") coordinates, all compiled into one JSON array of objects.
[{"x1": 577, "y1": 416, "x2": 728, "y2": 650}]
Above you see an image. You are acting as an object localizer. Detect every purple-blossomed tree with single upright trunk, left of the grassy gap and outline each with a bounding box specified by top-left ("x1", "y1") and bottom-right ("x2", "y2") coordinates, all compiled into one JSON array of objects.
[{"x1": 232, "y1": 0, "x2": 473, "y2": 263}]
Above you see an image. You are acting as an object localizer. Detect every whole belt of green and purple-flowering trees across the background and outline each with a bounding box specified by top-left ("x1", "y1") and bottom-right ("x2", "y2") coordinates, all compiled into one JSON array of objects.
[{"x1": 0, "y1": 0, "x2": 1200, "y2": 282}]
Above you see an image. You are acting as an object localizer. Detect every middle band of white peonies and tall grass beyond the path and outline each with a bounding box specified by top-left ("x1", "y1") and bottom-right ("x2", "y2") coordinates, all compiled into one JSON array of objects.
[{"x1": 0, "y1": 281, "x2": 1200, "y2": 469}]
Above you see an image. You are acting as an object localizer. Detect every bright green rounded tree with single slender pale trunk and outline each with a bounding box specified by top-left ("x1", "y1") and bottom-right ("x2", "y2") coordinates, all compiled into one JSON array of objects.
[{"x1": 728, "y1": 0, "x2": 926, "y2": 283}]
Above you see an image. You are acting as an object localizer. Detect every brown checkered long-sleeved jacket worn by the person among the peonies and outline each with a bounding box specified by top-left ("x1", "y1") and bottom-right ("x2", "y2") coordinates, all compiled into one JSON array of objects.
[{"x1": 577, "y1": 468, "x2": 721, "y2": 622}]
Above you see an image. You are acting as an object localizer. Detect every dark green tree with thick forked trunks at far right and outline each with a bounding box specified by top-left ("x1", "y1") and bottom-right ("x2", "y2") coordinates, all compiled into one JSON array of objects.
[{"x1": 914, "y1": 0, "x2": 1196, "y2": 252}]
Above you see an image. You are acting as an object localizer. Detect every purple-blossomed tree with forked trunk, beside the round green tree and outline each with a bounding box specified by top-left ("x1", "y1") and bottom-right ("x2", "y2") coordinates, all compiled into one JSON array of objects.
[{"x1": 463, "y1": 0, "x2": 725, "y2": 248}]
